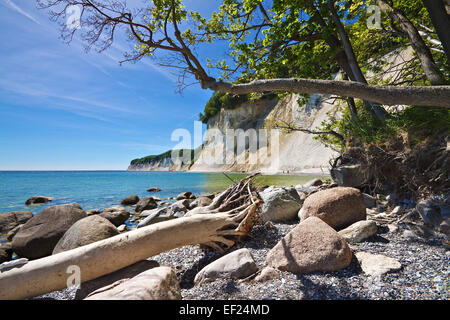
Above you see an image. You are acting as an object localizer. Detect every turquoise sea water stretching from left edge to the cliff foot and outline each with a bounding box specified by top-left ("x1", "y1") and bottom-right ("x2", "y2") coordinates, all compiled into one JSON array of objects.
[{"x1": 0, "y1": 171, "x2": 320, "y2": 214}]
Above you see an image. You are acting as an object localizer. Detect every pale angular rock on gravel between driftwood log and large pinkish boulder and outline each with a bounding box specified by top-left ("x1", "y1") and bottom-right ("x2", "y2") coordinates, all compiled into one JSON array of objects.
[{"x1": 194, "y1": 248, "x2": 258, "y2": 284}]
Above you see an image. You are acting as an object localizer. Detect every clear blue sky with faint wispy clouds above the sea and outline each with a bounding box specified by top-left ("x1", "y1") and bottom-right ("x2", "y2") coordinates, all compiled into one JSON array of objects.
[{"x1": 0, "y1": 0, "x2": 225, "y2": 170}]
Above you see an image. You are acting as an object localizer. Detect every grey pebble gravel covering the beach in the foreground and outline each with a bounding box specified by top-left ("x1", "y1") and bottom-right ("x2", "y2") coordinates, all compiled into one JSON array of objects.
[{"x1": 30, "y1": 222, "x2": 450, "y2": 300}]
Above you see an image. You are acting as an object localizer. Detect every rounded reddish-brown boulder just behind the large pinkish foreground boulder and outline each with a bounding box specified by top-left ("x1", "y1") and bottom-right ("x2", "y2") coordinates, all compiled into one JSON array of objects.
[{"x1": 298, "y1": 187, "x2": 366, "y2": 229}]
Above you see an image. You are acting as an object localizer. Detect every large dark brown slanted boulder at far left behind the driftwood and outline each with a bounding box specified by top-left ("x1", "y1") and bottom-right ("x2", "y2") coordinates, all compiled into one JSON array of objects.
[{"x1": 12, "y1": 203, "x2": 87, "y2": 259}]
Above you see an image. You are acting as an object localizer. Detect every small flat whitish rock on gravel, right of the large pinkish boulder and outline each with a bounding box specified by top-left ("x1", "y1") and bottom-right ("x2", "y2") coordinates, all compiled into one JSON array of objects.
[{"x1": 355, "y1": 252, "x2": 402, "y2": 276}]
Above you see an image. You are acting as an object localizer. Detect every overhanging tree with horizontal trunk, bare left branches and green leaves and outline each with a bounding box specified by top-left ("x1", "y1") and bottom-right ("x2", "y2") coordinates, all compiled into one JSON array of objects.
[{"x1": 37, "y1": 0, "x2": 450, "y2": 107}]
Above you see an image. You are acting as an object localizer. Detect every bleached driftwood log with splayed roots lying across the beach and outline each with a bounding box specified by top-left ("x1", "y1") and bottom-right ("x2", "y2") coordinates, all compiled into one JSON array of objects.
[{"x1": 0, "y1": 177, "x2": 262, "y2": 300}]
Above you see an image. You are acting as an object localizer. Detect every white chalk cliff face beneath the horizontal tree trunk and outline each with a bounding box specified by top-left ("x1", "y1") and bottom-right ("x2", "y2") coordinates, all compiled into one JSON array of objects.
[{"x1": 190, "y1": 95, "x2": 336, "y2": 174}]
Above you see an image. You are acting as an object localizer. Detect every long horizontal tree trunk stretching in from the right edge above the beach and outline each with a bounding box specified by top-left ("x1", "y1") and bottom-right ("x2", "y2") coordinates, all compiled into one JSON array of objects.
[{"x1": 201, "y1": 78, "x2": 450, "y2": 108}]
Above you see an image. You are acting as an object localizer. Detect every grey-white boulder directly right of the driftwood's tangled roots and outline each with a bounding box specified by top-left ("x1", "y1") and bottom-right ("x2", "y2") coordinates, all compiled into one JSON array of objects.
[{"x1": 260, "y1": 188, "x2": 302, "y2": 222}]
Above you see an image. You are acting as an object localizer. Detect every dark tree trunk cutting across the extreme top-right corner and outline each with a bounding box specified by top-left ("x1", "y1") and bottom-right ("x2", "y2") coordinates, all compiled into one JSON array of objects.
[{"x1": 423, "y1": 0, "x2": 450, "y2": 63}]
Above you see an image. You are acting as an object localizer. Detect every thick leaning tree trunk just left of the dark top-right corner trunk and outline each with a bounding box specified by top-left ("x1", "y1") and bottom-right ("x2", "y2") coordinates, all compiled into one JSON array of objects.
[{"x1": 377, "y1": 0, "x2": 445, "y2": 85}]
